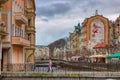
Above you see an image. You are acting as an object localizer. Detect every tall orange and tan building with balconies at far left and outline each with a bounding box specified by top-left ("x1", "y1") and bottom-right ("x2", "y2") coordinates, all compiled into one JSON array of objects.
[{"x1": 1, "y1": 0, "x2": 35, "y2": 71}]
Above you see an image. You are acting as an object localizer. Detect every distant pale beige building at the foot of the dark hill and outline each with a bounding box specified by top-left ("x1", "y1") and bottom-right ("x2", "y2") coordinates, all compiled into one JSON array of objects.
[{"x1": 35, "y1": 45, "x2": 50, "y2": 59}]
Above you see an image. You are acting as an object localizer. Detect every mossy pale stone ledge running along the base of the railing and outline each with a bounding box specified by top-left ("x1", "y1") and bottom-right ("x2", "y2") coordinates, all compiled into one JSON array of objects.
[{"x1": 2, "y1": 71, "x2": 120, "y2": 78}]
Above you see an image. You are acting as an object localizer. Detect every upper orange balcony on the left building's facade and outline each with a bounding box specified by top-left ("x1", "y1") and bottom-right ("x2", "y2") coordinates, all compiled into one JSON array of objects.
[{"x1": 15, "y1": 12, "x2": 28, "y2": 24}]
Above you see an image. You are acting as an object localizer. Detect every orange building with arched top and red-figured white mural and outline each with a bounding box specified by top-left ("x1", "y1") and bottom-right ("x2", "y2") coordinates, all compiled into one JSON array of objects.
[{"x1": 81, "y1": 14, "x2": 109, "y2": 55}]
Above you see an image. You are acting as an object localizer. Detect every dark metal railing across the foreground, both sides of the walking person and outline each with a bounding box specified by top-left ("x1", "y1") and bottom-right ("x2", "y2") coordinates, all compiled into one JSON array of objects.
[{"x1": 2, "y1": 62, "x2": 120, "y2": 72}]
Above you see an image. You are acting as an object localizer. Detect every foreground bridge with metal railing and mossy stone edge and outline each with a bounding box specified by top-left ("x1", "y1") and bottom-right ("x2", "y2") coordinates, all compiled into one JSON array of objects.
[{"x1": 0, "y1": 60, "x2": 120, "y2": 80}]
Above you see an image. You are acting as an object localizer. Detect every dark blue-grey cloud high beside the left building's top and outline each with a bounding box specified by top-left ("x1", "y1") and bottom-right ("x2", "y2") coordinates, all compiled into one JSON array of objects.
[{"x1": 37, "y1": 3, "x2": 71, "y2": 18}]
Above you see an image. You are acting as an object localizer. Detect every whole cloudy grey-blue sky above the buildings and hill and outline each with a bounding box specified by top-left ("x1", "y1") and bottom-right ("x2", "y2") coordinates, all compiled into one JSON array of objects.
[{"x1": 35, "y1": 0, "x2": 120, "y2": 45}]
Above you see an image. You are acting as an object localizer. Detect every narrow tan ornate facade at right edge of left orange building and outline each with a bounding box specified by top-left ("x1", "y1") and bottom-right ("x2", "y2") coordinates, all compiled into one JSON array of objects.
[{"x1": 25, "y1": 0, "x2": 36, "y2": 63}]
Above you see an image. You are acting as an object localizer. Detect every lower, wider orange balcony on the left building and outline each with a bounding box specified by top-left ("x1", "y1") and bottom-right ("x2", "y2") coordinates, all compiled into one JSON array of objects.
[{"x1": 12, "y1": 36, "x2": 30, "y2": 46}]
